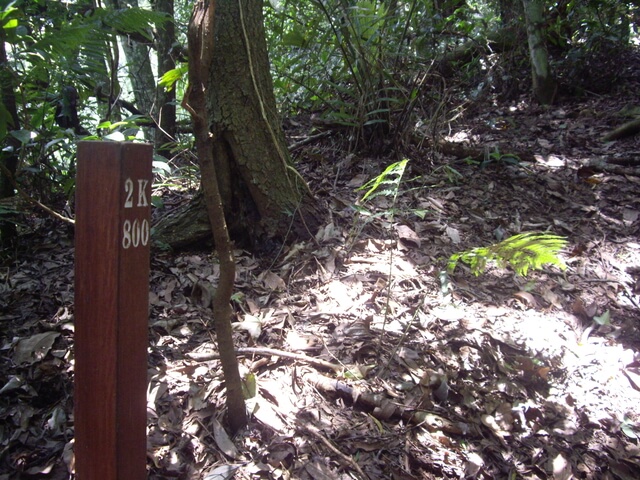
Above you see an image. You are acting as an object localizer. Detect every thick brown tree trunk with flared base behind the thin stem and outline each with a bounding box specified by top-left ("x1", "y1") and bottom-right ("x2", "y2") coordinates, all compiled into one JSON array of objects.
[{"x1": 155, "y1": 0, "x2": 321, "y2": 248}]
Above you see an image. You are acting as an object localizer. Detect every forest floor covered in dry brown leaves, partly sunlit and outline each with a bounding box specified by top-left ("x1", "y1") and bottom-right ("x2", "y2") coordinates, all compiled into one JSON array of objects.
[{"x1": 0, "y1": 81, "x2": 640, "y2": 480}]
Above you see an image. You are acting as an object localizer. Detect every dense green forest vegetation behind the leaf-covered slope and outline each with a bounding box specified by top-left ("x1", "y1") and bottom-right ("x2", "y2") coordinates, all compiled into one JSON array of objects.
[{"x1": 0, "y1": 0, "x2": 637, "y2": 229}]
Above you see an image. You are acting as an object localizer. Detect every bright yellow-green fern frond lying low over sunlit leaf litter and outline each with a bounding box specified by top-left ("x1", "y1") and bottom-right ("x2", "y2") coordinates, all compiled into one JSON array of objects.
[{"x1": 447, "y1": 232, "x2": 567, "y2": 276}]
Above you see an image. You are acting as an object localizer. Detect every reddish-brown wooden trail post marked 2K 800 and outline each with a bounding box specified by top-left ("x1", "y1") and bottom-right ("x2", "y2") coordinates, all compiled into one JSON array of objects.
[{"x1": 74, "y1": 142, "x2": 152, "y2": 480}]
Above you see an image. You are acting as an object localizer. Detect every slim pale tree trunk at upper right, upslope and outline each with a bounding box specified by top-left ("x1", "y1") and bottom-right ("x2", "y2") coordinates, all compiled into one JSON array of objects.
[{"x1": 522, "y1": 0, "x2": 557, "y2": 105}]
